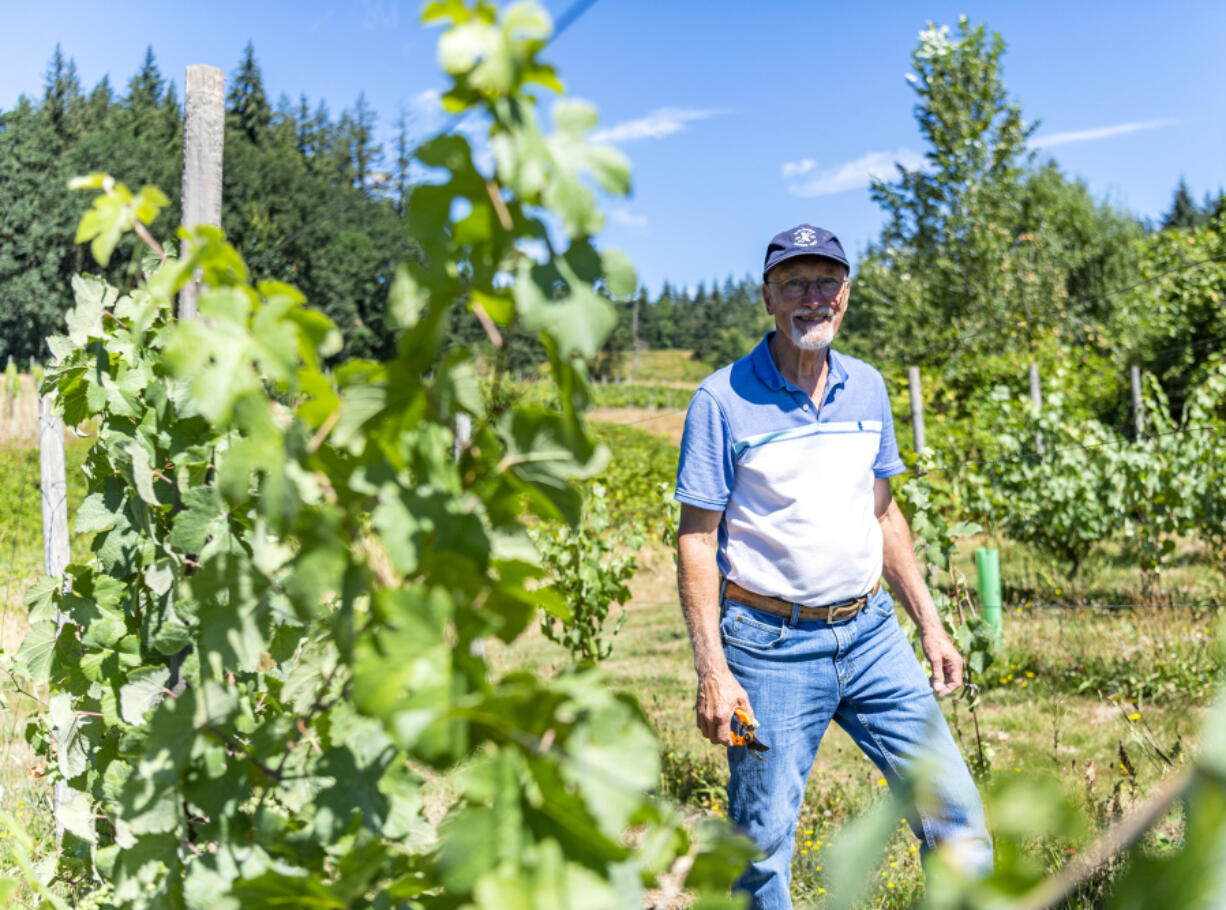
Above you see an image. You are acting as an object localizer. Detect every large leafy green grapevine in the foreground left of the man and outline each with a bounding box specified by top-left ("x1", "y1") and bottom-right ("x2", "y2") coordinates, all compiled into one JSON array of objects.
[{"x1": 20, "y1": 2, "x2": 748, "y2": 908}]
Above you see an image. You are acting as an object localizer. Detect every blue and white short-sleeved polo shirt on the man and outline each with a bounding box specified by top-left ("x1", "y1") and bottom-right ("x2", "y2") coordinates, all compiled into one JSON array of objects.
[{"x1": 676, "y1": 332, "x2": 904, "y2": 606}]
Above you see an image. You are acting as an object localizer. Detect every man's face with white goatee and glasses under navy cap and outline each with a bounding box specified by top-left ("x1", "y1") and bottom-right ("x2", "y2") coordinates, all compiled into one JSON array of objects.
[{"x1": 763, "y1": 256, "x2": 851, "y2": 351}]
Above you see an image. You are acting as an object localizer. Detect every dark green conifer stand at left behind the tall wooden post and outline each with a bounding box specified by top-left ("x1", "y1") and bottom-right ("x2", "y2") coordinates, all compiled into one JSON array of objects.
[{"x1": 0, "y1": 44, "x2": 414, "y2": 367}]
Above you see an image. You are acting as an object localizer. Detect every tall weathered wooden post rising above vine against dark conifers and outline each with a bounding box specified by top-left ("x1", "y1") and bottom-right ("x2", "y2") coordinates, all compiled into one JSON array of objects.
[{"x1": 179, "y1": 64, "x2": 226, "y2": 319}]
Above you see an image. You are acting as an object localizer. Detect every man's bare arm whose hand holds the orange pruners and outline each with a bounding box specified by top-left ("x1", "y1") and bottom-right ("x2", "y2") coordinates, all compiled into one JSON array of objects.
[{"x1": 677, "y1": 503, "x2": 753, "y2": 746}]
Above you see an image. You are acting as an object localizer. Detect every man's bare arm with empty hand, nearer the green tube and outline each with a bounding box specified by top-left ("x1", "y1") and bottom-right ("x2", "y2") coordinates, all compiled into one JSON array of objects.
[{"x1": 873, "y1": 477, "x2": 962, "y2": 695}]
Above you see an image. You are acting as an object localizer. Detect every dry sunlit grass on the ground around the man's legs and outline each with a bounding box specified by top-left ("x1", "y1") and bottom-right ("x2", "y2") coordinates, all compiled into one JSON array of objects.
[{"x1": 490, "y1": 534, "x2": 1220, "y2": 908}]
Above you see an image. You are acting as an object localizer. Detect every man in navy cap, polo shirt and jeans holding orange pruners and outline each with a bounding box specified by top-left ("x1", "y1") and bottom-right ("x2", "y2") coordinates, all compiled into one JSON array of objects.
[{"x1": 676, "y1": 224, "x2": 992, "y2": 910}]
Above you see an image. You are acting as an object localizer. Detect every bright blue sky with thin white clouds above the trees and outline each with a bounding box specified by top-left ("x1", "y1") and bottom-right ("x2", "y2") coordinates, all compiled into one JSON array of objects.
[{"x1": 0, "y1": 0, "x2": 1226, "y2": 291}]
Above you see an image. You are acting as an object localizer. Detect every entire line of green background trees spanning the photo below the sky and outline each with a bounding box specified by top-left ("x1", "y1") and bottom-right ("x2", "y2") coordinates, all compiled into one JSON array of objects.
[{"x1": 0, "y1": 30, "x2": 1226, "y2": 417}]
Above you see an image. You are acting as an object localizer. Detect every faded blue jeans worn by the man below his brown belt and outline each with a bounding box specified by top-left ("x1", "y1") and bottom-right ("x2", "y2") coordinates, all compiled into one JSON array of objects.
[{"x1": 720, "y1": 589, "x2": 992, "y2": 910}]
